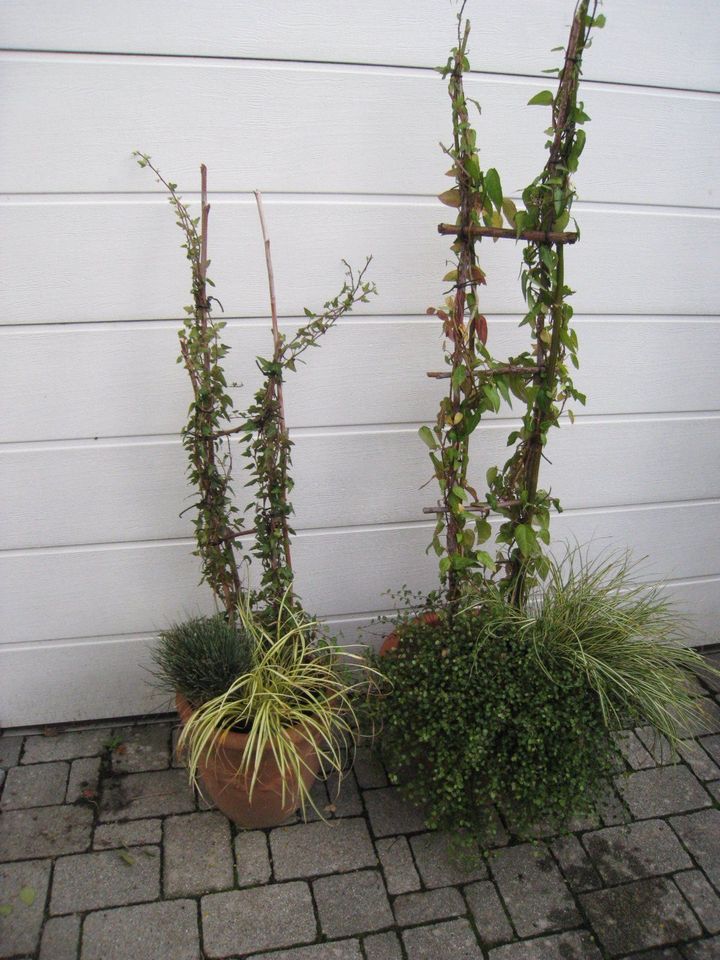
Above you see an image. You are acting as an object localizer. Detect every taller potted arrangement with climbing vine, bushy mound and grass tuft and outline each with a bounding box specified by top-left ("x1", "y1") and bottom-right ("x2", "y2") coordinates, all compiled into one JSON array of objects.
[{"x1": 374, "y1": 0, "x2": 703, "y2": 833}]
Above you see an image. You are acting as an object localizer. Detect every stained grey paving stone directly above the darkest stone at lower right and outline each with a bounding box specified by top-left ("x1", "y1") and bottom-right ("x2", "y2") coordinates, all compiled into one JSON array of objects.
[{"x1": 583, "y1": 820, "x2": 692, "y2": 883}]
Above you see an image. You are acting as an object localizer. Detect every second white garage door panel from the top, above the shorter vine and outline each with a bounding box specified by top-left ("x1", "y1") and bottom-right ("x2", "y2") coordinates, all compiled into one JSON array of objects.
[{"x1": 0, "y1": 54, "x2": 720, "y2": 207}]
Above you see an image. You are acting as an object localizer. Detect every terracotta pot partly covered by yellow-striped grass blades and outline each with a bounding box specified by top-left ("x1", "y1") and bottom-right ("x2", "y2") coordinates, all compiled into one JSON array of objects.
[{"x1": 175, "y1": 693, "x2": 320, "y2": 829}]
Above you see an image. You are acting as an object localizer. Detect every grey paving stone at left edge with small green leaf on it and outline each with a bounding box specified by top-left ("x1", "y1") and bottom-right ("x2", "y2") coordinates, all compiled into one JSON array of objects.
[{"x1": 0, "y1": 860, "x2": 50, "y2": 957}]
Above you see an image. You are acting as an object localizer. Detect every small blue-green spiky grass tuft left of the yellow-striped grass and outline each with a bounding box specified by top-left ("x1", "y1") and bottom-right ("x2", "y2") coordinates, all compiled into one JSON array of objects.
[{"x1": 152, "y1": 613, "x2": 253, "y2": 705}]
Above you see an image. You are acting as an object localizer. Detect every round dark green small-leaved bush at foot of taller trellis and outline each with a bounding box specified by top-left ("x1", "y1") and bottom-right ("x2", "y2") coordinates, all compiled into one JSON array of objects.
[{"x1": 375, "y1": 608, "x2": 617, "y2": 839}]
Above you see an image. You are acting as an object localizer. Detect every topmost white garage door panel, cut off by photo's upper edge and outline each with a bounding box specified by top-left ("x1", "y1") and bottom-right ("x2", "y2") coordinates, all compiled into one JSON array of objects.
[{"x1": 3, "y1": 0, "x2": 720, "y2": 90}]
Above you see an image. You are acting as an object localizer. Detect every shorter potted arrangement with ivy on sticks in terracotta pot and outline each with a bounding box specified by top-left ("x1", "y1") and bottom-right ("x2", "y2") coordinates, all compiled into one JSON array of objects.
[{"x1": 135, "y1": 153, "x2": 375, "y2": 827}]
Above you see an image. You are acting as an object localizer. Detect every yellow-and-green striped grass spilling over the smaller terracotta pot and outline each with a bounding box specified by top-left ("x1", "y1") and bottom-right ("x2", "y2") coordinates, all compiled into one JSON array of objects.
[{"x1": 178, "y1": 587, "x2": 374, "y2": 810}]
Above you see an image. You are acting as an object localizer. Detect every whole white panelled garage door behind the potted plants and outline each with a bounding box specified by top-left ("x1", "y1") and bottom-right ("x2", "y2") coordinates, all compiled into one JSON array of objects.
[{"x1": 0, "y1": 0, "x2": 720, "y2": 726}]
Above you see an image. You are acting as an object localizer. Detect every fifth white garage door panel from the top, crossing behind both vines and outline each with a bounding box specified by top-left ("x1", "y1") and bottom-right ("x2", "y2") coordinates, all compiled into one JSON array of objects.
[{"x1": 0, "y1": 416, "x2": 720, "y2": 549}]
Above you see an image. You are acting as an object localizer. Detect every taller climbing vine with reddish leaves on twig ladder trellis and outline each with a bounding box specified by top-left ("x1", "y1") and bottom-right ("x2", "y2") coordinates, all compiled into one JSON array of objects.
[{"x1": 420, "y1": 0, "x2": 604, "y2": 613}]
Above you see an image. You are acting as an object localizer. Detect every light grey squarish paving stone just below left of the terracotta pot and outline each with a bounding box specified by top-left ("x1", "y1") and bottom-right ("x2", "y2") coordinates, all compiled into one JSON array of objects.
[{"x1": 163, "y1": 811, "x2": 235, "y2": 897}]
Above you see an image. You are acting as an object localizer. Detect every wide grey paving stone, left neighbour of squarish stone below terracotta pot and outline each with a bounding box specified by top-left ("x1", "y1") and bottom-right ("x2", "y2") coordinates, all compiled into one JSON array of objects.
[{"x1": 50, "y1": 847, "x2": 160, "y2": 915}]
